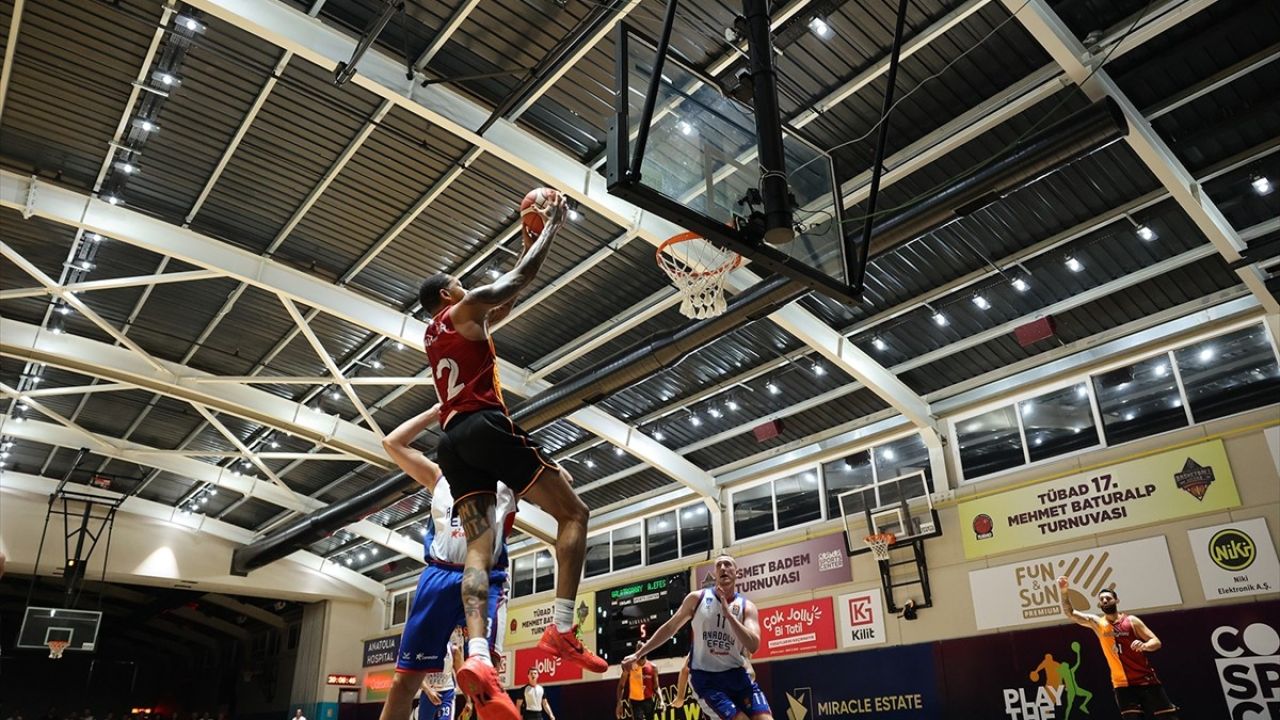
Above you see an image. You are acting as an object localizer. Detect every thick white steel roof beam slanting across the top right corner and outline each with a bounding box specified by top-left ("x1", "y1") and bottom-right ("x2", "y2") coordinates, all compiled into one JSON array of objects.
[{"x1": 1004, "y1": 0, "x2": 1280, "y2": 314}]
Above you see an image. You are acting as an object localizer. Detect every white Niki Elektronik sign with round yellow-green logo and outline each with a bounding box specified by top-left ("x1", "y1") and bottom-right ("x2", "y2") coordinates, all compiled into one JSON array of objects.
[{"x1": 1187, "y1": 518, "x2": 1280, "y2": 600}]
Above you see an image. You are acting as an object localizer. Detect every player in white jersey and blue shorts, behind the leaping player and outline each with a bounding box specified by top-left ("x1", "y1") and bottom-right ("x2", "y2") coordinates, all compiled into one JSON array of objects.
[{"x1": 380, "y1": 405, "x2": 516, "y2": 720}]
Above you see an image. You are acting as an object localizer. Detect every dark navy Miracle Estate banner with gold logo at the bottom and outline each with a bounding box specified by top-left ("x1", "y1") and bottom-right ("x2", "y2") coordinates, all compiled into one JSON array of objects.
[{"x1": 762, "y1": 644, "x2": 942, "y2": 720}]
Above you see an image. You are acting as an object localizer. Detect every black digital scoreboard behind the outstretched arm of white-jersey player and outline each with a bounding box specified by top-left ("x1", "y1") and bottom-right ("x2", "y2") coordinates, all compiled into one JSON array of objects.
[{"x1": 595, "y1": 573, "x2": 689, "y2": 665}]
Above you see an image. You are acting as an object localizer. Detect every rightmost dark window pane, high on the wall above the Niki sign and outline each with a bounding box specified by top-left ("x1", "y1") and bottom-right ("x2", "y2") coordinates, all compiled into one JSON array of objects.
[{"x1": 1174, "y1": 325, "x2": 1280, "y2": 423}]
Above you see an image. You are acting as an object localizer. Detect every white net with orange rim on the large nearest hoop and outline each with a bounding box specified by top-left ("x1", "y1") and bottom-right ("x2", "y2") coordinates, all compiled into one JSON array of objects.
[{"x1": 657, "y1": 233, "x2": 742, "y2": 320}]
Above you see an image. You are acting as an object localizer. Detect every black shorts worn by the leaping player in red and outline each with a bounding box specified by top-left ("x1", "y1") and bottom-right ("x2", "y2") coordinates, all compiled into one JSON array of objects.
[{"x1": 436, "y1": 407, "x2": 557, "y2": 503}]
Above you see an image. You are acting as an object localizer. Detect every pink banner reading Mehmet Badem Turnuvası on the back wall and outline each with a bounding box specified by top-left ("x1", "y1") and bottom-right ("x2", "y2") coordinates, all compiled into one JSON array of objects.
[{"x1": 694, "y1": 533, "x2": 852, "y2": 597}]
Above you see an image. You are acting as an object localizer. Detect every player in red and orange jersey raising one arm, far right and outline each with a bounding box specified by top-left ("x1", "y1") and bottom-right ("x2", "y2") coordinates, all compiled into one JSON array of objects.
[{"x1": 1057, "y1": 577, "x2": 1178, "y2": 720}]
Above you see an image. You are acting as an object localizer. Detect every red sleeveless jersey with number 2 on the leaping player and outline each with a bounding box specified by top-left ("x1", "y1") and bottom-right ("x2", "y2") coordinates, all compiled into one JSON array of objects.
[{"x1": 422, "y1": 305, "x2": 507, "y2": 428}]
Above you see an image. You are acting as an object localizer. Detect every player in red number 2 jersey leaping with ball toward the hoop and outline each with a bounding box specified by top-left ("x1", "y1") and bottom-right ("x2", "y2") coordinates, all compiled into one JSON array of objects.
[{"x1": 419, "y1": 196, "x2": 608, "y2": 720}]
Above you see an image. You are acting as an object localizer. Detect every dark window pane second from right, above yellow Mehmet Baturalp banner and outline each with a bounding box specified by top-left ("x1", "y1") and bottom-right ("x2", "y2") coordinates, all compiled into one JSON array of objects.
[{"x1": 1093, "y1": 354, "x2": 1189, "y2": 445}]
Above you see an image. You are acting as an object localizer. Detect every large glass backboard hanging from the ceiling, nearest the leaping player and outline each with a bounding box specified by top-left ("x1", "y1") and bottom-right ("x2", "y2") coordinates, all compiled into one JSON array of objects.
[{"x1": 608, "y1": 23, "x2": 861, "y2": 302}]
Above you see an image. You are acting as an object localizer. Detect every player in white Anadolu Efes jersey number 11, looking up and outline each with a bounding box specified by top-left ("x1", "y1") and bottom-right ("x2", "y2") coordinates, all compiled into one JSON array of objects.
[{"x1": 622, "y1": 555, "x2": 773, "y2": 720}]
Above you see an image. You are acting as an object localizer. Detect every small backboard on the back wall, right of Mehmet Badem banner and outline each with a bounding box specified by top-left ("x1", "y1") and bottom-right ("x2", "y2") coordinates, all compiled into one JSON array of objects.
[{"x1": 838, "y1": 471, "x2": 942, "y2": 555}]
